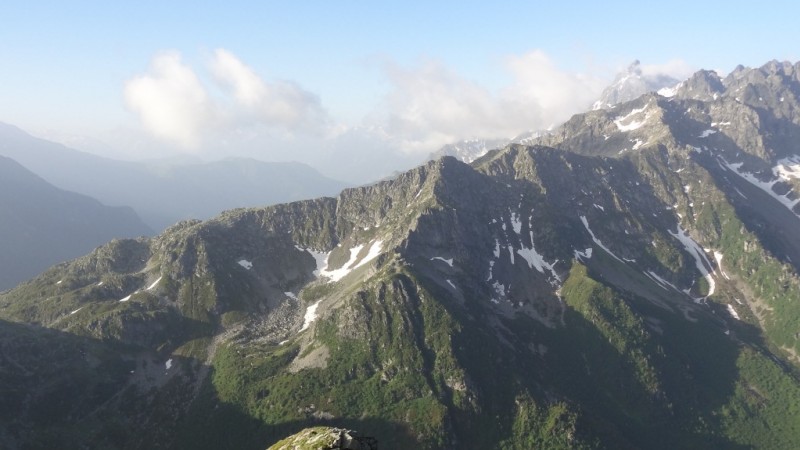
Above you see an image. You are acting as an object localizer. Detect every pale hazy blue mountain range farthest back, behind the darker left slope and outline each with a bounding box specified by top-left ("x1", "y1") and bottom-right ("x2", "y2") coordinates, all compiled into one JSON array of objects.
[{"x1": 0, "y1": 123, "x2": 345, "y2": 230}]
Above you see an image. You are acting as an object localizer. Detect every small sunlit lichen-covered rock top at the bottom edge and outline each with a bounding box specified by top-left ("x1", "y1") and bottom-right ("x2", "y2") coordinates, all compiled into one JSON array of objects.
[{"x1": 267, "y1": 427, "x2": 378, "y2": 450}]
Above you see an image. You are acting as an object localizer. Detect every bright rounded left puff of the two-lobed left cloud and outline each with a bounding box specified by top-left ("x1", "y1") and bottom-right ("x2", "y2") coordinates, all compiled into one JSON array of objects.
[{"x1": 124, "y1": 52, "x2": 214, "y2": 148}]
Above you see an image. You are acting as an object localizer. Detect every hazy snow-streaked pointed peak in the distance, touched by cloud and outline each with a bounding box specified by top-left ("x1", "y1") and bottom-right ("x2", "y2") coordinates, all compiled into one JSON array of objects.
[{"x1": 592, "y1": 60, "x2": 679, "y2": 110}]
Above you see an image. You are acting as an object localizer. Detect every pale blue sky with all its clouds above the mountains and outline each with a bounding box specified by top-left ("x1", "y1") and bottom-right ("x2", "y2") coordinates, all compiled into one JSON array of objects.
[{"x1": 0, "y1": 0, "x2": 800, "y2": 182}]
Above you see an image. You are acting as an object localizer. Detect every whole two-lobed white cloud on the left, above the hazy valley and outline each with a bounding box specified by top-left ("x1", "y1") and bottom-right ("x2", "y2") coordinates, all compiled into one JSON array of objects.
[{"x1": 124, "y1": 49, "x2": 329, "y2": 150}]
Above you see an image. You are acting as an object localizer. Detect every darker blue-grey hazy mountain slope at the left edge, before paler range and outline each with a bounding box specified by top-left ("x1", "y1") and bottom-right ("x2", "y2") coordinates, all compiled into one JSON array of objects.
[{"x1": 0, "y1": 156, "x2": 153, "y2": 291}]
